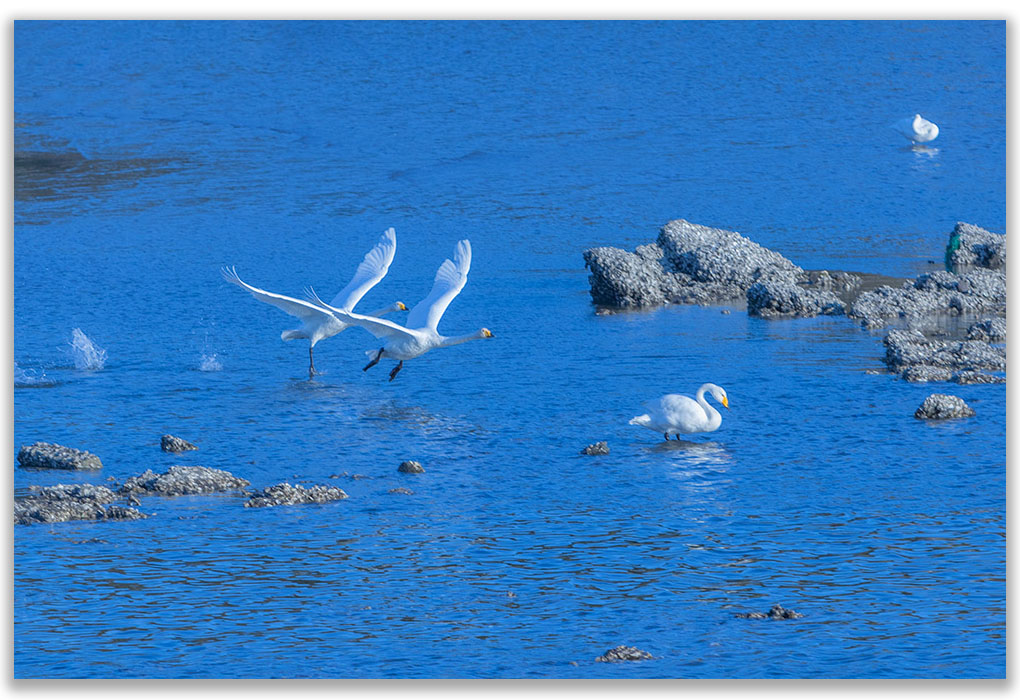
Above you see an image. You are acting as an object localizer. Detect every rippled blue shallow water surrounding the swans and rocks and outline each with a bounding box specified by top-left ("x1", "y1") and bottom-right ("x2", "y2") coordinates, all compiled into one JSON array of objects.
[{"x1": 14, "y1": 22, "x2": 1006, "y2": 678}]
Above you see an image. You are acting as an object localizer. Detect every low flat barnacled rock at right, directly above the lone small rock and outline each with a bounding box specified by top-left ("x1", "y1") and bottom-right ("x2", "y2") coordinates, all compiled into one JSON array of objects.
[{"x1": 882, "y1": 330, "x2": 1006, "y2": 382}]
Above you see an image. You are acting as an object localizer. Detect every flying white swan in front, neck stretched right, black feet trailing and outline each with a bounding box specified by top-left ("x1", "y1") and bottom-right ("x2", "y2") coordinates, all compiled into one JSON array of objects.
[{"x1": 310, "y1": 240, "x2": 493, "y2": 382}]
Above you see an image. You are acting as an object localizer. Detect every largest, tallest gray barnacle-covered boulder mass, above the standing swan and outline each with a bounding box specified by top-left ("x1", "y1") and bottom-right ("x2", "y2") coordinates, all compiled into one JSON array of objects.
[{"x1": 584, "y1": 219, "x2": 807, "y2": 307}]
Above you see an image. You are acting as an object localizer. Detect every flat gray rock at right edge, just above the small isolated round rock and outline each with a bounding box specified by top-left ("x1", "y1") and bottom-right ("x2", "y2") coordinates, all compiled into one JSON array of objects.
[{"x1": 882, "y1": 330, "x2": 1006, "y2": 384}]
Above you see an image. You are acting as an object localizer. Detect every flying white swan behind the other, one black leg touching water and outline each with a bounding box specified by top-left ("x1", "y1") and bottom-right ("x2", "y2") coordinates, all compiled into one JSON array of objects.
[{"x1": 220, "y1": 229, "x2": 407, "y2": 379}]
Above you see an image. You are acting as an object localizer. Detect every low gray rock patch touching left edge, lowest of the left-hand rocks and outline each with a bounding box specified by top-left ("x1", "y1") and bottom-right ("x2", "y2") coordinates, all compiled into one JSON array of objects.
[{"x1": 14, "y1": 484, "x2": 147, "y2": 524}]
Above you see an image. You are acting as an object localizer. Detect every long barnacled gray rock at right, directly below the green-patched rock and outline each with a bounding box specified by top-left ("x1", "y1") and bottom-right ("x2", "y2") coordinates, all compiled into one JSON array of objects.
[{"x1": 848, "y1": 268, "x2": 1006, "y2": 329}]
